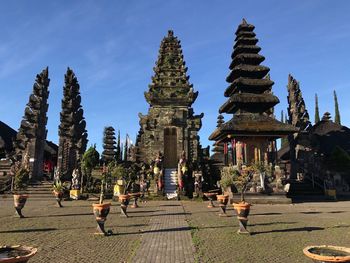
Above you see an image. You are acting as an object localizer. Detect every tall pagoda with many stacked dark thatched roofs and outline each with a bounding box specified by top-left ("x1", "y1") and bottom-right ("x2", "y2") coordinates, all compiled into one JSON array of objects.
[{"x1": 209, "y1": 19, "x2": 297, "y2": 164}]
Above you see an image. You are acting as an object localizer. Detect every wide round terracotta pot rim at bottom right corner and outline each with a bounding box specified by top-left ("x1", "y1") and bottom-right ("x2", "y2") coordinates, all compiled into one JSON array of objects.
[{"x1": 303, "y1": 246, "x2": 350, "y2": 262}]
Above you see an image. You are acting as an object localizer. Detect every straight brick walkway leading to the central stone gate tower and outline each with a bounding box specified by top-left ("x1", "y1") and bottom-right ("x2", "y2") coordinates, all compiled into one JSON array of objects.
[{"x1": 132, "y1": 201, "x2": 194, "y2": 263}]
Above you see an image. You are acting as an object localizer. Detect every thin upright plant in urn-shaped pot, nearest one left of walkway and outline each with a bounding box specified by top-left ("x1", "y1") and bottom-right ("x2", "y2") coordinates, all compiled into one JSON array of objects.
[{"x1": 92, "y1": 167, "x2": 111, "y2": 236}]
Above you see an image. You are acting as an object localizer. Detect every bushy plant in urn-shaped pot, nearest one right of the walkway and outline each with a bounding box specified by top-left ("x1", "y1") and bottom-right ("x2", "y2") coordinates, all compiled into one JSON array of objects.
[{"x1": 231, "y1": 166, "x2": 255, "y2": 234}]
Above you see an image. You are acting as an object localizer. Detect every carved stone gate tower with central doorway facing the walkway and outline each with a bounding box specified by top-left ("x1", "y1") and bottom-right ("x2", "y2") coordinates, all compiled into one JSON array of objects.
[{"x1": 136, "y1": 30, "x2": 203, "y2": 168}]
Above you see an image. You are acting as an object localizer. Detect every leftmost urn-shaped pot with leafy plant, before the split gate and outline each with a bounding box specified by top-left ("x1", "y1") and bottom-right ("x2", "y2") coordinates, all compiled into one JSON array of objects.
[{"x1": 13, "y1": 167, "x2": 29, "y2": 218}]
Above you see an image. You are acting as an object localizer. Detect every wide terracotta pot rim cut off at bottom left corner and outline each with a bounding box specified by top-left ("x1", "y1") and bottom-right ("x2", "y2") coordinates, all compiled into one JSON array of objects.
[{"x1": 0, "y1": 246, "x2": 38, "y2": 263}]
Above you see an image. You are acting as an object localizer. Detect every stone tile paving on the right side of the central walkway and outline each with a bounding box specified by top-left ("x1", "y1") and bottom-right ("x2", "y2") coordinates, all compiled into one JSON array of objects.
[{"x1": 182, "y1": 201, "x2": 350, "y2": 262}]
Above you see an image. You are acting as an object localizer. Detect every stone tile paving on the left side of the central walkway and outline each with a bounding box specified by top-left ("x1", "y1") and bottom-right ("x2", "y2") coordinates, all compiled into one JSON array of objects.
[{"x1": 0, "y1": 199, "x2": 156, "y2": 263}]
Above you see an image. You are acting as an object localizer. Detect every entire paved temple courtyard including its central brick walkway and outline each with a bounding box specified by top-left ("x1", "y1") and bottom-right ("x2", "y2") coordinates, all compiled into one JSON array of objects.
[{"x1": 0, "y1": 197, "x2": 350, "y2": 263}]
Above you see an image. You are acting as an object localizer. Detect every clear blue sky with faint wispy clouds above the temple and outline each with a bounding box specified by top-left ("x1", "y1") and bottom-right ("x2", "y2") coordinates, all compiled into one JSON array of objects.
[{"x1": 0, "y1": 0, "x2": 350, "y2": 154}]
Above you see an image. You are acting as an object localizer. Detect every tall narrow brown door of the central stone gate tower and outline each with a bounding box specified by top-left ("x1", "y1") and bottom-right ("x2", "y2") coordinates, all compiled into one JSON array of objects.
[{"x1": 164, "y1": 128, "x2": 177, "y2": 168}]
